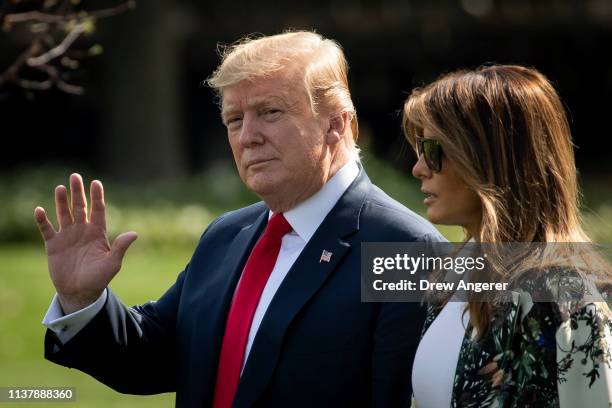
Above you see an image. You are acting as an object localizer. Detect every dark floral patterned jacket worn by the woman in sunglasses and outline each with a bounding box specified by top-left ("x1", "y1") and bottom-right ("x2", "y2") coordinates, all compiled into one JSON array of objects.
[{"x1": 412, "y1": 270, "x2": 612, "y2": 408}]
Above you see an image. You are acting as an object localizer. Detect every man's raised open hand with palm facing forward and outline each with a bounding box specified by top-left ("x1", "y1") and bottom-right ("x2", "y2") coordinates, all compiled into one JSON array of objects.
[{"x1": 34, "y1": 173, "x2": 138, "y2": 314}]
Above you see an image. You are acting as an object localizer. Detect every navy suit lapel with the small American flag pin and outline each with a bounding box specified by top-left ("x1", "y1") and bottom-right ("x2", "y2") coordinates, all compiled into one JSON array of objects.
[{"x1": 234, "y1": 169, "x2": 371, "y2": 407}]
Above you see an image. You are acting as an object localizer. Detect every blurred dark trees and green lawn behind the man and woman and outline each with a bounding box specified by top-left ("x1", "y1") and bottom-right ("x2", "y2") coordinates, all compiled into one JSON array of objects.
[{"x1": 0, "y1": 0, "x2": 612, "y2": 407}]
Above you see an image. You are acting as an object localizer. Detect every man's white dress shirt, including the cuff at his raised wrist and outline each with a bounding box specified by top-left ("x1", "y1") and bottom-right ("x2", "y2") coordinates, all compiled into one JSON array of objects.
[{"x1": 42, "y1": 161, "x2": 359, "y2": 368}]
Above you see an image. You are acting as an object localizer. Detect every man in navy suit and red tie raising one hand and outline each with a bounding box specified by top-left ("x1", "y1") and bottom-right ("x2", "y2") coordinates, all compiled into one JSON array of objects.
[{"x1": 36, "y1": 32, "x2": 441, "y2": 407}]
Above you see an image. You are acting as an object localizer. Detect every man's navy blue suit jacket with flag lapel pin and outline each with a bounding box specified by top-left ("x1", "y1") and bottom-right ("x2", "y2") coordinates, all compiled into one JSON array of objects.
[{"x1": 45, "y1": 169, "x2": 442, "y2": 408}]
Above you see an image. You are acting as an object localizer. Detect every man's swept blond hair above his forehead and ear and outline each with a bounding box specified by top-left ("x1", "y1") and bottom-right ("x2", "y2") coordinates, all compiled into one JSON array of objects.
[{"x1": 206, "y1": 31, "x2": 358, "y2": 141}]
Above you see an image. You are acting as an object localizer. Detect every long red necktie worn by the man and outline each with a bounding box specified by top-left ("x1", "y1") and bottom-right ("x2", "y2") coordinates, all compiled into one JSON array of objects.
[{"x1": 213, "y1": 213, "x2": 291, "y2": 408}]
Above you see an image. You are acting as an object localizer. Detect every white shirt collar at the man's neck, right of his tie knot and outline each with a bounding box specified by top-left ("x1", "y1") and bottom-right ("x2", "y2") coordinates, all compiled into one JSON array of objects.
[{"x1": 269, "y1": 160, "x2": 359, "y2": 242}]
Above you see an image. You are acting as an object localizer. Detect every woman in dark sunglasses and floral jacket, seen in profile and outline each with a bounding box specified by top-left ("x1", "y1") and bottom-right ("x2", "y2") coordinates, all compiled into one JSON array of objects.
[{"x1": 403, "y1": 65, "x2": 612, "y2": 408}]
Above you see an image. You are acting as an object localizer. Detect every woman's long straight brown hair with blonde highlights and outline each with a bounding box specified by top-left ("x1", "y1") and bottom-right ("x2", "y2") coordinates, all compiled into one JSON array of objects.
[{"x1": 403, "y1": 65, "x2": 608, "y2": 334}]
